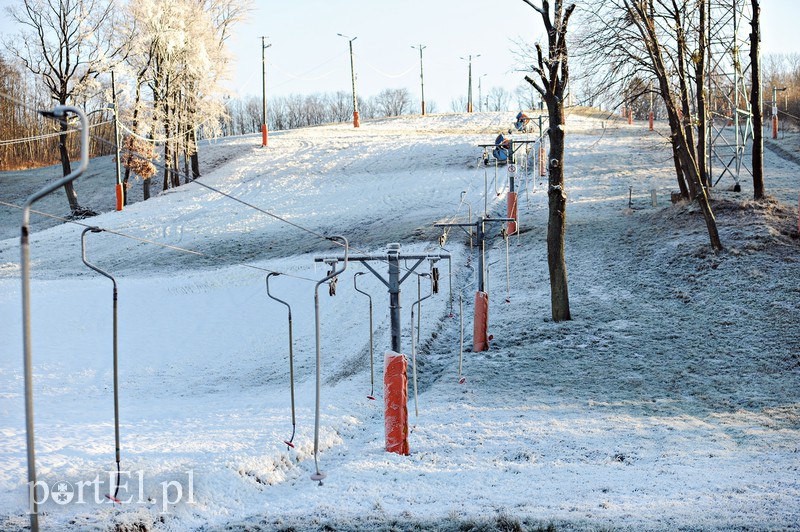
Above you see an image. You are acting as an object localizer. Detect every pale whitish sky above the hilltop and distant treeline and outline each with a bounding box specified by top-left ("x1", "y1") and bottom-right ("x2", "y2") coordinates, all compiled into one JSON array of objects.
[{"x1": 0, "y1": 0, "x2": 800, "y2": 112}]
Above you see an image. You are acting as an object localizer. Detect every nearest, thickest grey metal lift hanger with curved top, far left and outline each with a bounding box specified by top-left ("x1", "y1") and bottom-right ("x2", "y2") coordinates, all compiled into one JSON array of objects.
[{"x1": 20, "y1": 105, "x2": 89, "y2": 532}]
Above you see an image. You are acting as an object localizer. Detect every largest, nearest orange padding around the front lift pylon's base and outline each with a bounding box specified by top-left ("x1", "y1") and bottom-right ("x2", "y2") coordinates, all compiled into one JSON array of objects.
[{"x1": 383, "y1": 351, "x2": 411, "y2": 456}]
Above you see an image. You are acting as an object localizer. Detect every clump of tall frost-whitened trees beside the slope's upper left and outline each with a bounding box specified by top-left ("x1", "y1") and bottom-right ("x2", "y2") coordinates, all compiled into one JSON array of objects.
[{"x1": 123, "y1": 0, "x2": 250, "y2": 193}]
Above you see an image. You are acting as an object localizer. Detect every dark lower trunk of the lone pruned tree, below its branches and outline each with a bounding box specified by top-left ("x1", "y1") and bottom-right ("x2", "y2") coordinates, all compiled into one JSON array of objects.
[{"x1": 547, "y1": 97, "x2": 572, "y2": 321}]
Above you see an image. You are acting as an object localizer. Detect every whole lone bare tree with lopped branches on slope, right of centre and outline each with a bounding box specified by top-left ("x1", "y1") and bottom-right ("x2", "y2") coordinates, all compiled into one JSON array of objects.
[{"x1": 523, "y1": 0, "x2": 575, "y2": 321}]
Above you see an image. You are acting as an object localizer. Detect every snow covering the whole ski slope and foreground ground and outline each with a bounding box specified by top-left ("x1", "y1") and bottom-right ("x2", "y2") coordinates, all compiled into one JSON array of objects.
[{"x1": 0, "y1": 113, "x2": 800, "y2": 530}]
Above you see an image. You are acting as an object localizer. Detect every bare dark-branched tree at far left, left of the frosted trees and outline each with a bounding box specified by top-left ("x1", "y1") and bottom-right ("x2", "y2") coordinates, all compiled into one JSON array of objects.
[{"x1": 6, "y1": 0, "x2": 120, "y2": 217}]
